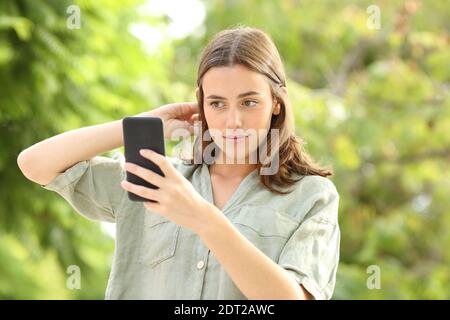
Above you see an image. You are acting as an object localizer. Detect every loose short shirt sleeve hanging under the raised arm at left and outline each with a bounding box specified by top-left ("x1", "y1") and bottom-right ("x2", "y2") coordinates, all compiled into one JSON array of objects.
[{"x1": 41, "y1": 156, "x2": 126, "y2": 222}]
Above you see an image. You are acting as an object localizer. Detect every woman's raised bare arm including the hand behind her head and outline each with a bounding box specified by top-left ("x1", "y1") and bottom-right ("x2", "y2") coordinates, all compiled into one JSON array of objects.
[{"x1": 17, "y1": 102, "x2": 198, "y2": 185}]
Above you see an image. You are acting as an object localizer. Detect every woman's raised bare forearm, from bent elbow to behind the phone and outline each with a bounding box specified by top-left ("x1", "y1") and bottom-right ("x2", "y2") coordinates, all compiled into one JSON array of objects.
[{"x1": 17, "y1": 112, "x2": 151, "y2": 185}]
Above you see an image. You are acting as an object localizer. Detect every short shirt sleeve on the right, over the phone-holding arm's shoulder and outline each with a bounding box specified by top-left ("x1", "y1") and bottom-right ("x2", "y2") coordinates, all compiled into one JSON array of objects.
[{"x1": 278, "y1": 179, "x2": 340, "y2": 300}]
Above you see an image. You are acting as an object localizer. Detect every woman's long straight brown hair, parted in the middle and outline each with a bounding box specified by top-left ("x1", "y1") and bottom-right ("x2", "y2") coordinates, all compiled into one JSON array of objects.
[{"x1": 185, "y1": 27, "x2": 333, "y2": 194}]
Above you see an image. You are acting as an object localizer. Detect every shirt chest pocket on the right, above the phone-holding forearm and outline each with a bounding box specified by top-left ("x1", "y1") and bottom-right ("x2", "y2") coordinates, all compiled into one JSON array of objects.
[{"x1": 230, "y1": 205, "x2": 299, "y2": 261}]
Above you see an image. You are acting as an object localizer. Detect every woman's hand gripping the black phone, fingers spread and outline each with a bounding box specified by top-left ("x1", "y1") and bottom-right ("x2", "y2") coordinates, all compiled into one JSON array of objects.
[{"x1": 121, "y1": 149, "x2": 213, "y2": 233}]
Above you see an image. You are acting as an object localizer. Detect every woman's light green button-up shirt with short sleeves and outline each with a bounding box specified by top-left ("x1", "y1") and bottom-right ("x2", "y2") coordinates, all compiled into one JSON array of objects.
[{"x1": 42, "y1": 156, "x2": 340, "y2": 299}]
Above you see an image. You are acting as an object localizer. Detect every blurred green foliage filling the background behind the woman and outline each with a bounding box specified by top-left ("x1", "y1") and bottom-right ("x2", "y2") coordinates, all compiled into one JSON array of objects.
[{"x1": 0, "y1": 0, "x2": 450, "y2": 299}]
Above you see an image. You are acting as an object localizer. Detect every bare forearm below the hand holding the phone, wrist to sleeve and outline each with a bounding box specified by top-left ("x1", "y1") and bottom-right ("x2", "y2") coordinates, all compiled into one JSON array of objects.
[{"x1": 198, "y1": 205, "x2": 311, "y2": 300}]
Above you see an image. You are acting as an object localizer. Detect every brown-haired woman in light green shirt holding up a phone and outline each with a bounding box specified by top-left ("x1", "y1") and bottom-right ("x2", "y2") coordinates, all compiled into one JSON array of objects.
[{"x1": 18, "y1": 28, "x2": 340, "y2": 299}]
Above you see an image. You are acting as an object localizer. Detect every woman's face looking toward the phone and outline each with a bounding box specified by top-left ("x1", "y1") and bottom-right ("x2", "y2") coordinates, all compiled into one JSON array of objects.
[{"x1": 202, "y1": 65, "x2": 280, "y2": 163}]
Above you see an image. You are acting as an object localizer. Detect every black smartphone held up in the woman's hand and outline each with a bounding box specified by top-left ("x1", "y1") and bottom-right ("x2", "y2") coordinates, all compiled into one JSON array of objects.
[{"x1": 122, "y1": 117, "x2": 165, "y2": 202}]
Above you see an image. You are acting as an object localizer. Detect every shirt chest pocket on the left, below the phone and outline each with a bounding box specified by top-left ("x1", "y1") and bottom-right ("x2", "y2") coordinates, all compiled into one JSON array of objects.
[{"x1": 139, "y1": 211, "x2": 181, "y2": 268}]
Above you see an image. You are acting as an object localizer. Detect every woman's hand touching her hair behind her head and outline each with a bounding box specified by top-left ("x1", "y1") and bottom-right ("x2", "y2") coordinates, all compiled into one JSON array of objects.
[{"x1": 148, "y1": 102, "x2": 198, "y2": 139}]
